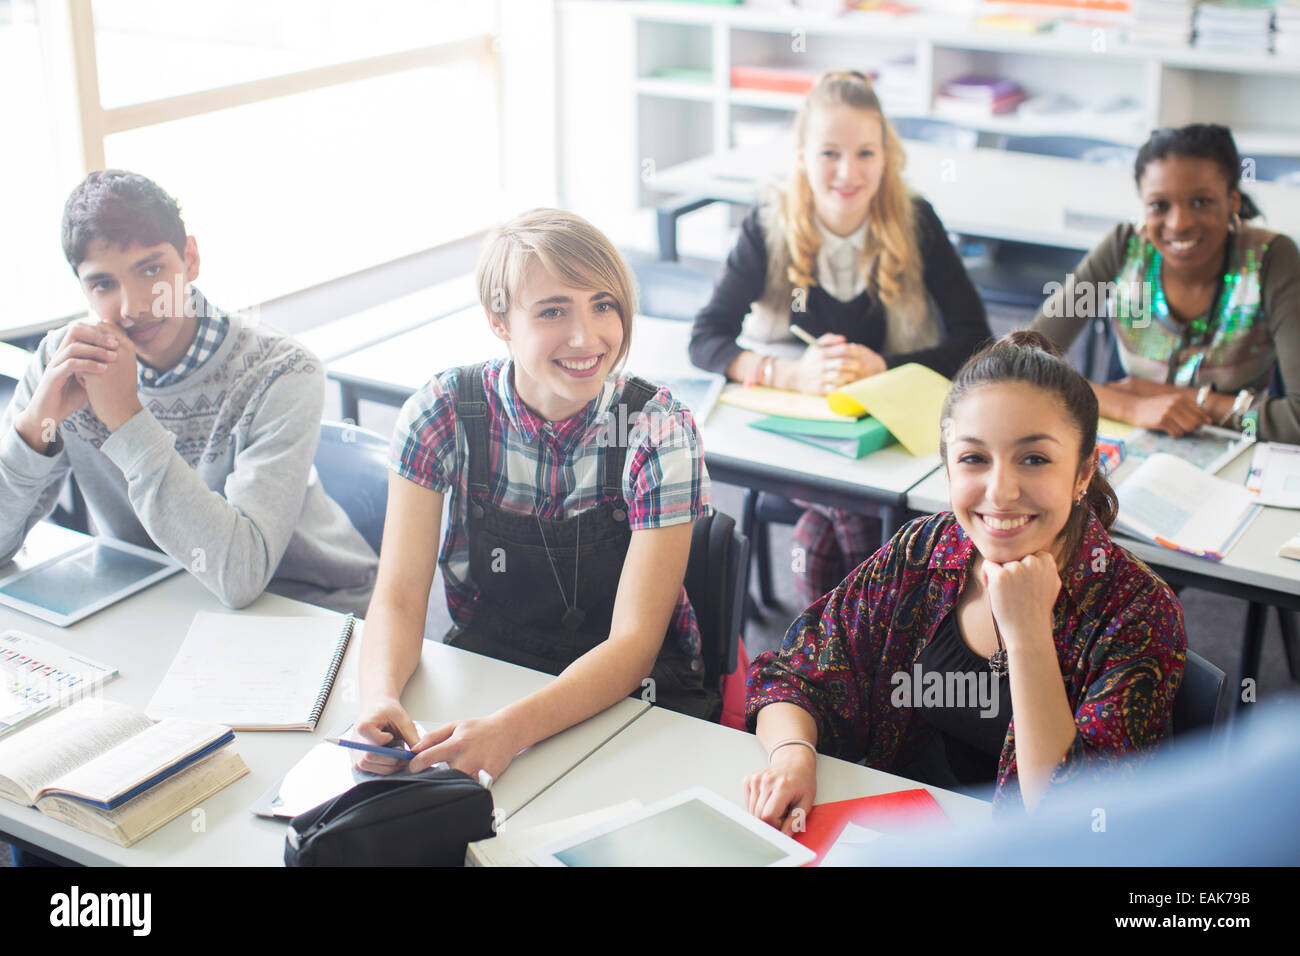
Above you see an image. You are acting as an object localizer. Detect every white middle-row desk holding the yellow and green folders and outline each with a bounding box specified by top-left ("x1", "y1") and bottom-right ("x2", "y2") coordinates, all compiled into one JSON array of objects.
[{"x1": 328, "y1": 314, "x2": 940, "y2": 533}]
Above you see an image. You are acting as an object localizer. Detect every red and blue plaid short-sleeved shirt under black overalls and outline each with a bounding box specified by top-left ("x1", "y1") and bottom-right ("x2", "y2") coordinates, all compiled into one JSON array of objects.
[{"x1": 389, "y1": 360, "x2": 710, "y2": 656}]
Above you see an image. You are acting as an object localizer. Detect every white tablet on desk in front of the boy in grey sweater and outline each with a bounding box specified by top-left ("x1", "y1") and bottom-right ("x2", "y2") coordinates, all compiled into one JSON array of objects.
[{"x1": 0, "y1": 537, "x2": 181, "y2": 627}]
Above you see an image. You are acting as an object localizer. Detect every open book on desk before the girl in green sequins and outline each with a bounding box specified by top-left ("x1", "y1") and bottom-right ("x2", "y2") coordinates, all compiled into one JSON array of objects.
[{"x1": 1115, "y1": 453, "x2": 1260, "y2": 561}]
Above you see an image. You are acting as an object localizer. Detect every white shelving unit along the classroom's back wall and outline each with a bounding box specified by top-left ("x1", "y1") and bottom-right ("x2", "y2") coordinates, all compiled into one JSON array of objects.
[{"x1": 558, "y1": 0, "x2": 1300, "y2": 251}]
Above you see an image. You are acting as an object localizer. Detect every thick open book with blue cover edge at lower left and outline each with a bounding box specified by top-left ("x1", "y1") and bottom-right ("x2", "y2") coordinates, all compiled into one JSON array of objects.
[{"x1": 0, "y1": 698, "x2": 248, "y2": 847}]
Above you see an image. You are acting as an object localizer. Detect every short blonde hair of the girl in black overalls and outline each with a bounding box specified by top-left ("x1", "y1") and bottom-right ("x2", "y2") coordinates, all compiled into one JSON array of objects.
[{"x1": 475, "y1": 208, "x2": 637, "y2": 365}]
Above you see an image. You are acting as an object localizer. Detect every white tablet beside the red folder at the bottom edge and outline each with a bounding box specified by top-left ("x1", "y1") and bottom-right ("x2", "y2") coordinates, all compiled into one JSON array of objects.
[{"x1": 528, "y1": 787, "x2": 816, "y2": 866}]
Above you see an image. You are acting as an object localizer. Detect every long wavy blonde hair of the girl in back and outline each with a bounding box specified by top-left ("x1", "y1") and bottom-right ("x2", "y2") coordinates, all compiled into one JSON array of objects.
[{"x1": 781, "y1": 70, "x2": 923, "y2": 317}]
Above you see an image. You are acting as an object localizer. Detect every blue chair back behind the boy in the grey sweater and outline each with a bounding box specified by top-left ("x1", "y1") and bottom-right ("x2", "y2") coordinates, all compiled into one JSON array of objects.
[{"x1": 313, "y1": 421, "x2": 389, "y2": 554}]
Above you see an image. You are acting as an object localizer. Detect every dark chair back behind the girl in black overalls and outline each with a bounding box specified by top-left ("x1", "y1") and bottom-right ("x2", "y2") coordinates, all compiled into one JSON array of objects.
[{"x1": 685, "y1": 511, "x2": 749, "y2": 689}]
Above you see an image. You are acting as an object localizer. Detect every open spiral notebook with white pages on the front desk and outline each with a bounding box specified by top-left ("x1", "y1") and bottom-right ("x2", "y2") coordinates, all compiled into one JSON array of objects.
[{"x1": 146, "y1": 611, "x2": 356, "y2": 731}]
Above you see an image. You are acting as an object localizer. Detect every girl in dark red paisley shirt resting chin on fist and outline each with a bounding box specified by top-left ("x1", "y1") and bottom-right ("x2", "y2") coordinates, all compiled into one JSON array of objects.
[{"x1": 745, "y1": 332, "x2": 1187, "y2": 831}]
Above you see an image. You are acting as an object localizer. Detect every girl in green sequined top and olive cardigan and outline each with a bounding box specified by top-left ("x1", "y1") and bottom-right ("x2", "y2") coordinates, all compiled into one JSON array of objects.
[{"x1": 1032, "y1": 124, "x2": 1300, "y2": 442}]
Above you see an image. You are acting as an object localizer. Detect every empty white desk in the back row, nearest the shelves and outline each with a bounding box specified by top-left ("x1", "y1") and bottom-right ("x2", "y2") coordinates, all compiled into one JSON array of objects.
[{"x1": 654, "y1": 137, "x2": 1300, "y2": 250}]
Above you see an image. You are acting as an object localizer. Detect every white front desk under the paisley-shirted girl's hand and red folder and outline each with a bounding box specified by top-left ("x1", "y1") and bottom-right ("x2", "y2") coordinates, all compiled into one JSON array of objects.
[{"x1": 507, "y1": 708, "x2": 992, "y2": 829}]
